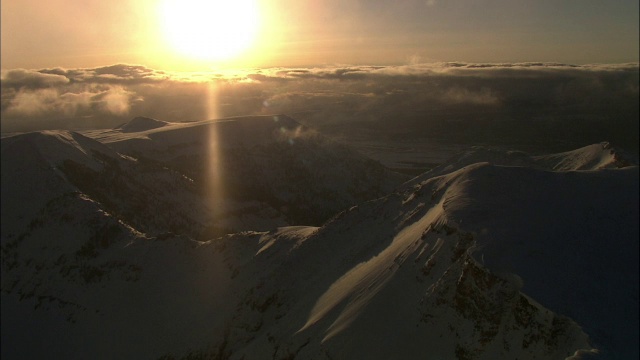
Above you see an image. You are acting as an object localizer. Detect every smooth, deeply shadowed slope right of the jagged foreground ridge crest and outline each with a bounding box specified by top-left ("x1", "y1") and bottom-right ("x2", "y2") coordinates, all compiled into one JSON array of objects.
[{"x1": 436, "y1": 165, "x2": 640, "y2": 358}]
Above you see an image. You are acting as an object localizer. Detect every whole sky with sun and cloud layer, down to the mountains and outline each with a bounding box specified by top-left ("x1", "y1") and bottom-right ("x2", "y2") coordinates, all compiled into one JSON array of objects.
[{"x1": 0, "y1": 0, "x2": 640, "y2": 150}]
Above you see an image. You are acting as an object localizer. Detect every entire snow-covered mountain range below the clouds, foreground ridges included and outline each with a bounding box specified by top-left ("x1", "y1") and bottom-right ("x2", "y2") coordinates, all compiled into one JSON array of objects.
[{"x1": 2, "y1": 117, "x2": 638, "y2": 359}]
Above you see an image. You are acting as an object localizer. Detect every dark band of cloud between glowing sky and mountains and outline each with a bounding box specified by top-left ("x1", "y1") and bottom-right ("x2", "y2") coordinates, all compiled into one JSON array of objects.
[{"x1": 1, "y1": 63, "x2": 639, "y2": 150}]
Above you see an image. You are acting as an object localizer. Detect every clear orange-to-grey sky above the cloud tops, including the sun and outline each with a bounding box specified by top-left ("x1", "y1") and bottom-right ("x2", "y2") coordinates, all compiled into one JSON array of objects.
[{"x1": 1, "y1": 0, "x2": 639, "y2": 71}]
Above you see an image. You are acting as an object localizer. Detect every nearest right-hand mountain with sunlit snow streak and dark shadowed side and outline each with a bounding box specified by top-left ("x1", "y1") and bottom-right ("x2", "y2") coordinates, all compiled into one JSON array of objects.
[{"x1": 219, "y1": 164, "x2": 638, "y2": 359}]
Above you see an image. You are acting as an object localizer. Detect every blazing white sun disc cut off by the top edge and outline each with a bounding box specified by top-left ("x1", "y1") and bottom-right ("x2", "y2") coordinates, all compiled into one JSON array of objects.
[{"x1": 160, "y1": 0, "x2": 260, "y2": 61}]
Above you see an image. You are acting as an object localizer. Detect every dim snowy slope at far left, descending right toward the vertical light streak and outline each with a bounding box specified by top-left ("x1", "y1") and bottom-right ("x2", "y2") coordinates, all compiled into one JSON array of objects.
[{"x1": 2, "y1": 131, "x2": 235, "y2": 236}]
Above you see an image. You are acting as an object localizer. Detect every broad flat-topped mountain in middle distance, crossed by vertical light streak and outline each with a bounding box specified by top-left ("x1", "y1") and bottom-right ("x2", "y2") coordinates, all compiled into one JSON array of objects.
[{"x1": 84, "y1": 115, "x2": 407, "y2": 228}]
